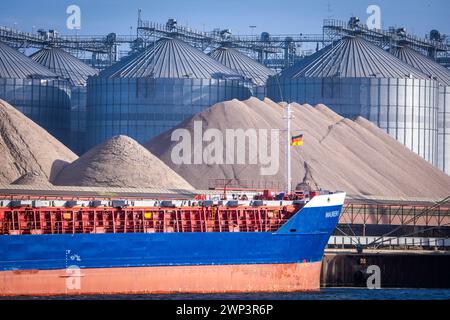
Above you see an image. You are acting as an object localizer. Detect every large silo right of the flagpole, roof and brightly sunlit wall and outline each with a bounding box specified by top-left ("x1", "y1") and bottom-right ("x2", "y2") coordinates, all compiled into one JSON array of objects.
[{"x1": 268, "y1": 36, "x2": 438, "y2": 164}]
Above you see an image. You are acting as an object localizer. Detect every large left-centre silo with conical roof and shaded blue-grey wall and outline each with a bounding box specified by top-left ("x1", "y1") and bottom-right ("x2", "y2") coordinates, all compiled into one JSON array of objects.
[{"x1": 87, "y1": 38, "x2": 250, "y2": 146}]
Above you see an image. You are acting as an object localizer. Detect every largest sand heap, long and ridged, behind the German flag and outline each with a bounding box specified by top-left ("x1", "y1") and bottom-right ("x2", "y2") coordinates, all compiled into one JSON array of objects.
[{"x1": 145, "y1": 98, "x2": 450, "y2": 199}]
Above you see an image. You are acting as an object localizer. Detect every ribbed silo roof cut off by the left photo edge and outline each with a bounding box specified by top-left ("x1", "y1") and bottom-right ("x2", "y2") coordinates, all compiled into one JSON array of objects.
[{"x1": 0, "y1": 42, "x2": 57, "y2": 79}]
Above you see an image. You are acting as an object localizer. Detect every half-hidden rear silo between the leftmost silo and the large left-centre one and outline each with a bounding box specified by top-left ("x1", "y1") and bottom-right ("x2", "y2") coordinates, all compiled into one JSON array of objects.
[{"x1": 31, "y1": 48, "x2": 98, "y2": 154}]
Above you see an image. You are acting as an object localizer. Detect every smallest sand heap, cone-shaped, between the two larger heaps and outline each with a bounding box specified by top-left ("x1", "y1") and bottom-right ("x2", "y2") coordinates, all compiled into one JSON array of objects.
[{"x1": 54, "y1": 136, "x2": 192, "y2": 189}]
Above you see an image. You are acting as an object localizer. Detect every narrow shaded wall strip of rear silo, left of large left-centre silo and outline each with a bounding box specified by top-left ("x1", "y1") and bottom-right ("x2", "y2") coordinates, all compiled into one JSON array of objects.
[{"x1": 70, "y1": 86, "x2": 87, "y2": 155}]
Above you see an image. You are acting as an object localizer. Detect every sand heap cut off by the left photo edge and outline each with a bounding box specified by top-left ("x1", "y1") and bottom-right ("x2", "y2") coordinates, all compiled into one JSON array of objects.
[{"x1": 0, "y1": 100, "x2": 77, "y2": 184}]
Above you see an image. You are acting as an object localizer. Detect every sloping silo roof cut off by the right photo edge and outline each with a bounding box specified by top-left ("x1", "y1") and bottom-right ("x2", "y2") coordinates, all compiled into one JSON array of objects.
[{"x1": 392, "y1": 47, "x2": 450, "y2": 86}]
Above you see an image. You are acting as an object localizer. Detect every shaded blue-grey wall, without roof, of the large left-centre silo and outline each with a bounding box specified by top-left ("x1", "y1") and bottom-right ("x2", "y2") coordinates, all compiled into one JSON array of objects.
[{"x1": 87, "y1": 77, "x2": 250, "y2": 147}]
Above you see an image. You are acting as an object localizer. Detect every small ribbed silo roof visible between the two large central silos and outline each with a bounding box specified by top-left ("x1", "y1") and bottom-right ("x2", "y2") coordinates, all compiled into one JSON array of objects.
[{"x1": 210, "y1": 46, "x2": 276, "y2": 85}]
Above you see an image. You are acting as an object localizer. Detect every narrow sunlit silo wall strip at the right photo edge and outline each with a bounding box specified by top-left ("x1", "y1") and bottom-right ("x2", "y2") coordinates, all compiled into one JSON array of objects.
[{"x1": 438, "y1": 86, "x2": 450, "y2": 175}]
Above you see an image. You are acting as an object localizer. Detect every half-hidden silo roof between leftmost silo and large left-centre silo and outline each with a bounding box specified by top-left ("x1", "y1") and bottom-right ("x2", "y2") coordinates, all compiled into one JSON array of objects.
[{"x1": 30, "y1": 48, "x2": 98, "y2": 86}]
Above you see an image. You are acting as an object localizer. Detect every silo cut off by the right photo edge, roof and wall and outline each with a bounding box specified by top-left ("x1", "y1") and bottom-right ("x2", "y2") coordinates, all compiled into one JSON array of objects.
[{"x1": 392, "y1": 47, "x2": 450, "y2": 174}]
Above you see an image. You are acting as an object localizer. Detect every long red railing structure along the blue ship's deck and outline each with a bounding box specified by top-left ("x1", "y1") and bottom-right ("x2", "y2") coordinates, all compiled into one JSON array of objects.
[{"x1": 0, "y1": 210, "x2": 292, "y2": 235}]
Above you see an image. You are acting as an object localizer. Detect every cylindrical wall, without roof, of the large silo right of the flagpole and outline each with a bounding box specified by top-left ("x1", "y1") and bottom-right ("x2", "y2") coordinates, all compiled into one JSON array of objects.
[{"x1": 268, "y1": 78, "x2": 438, "y2": 164}]
